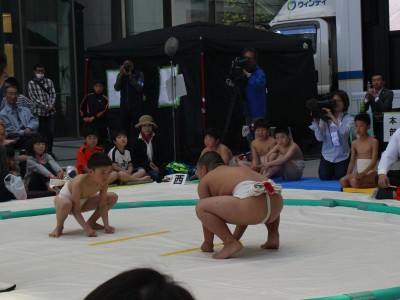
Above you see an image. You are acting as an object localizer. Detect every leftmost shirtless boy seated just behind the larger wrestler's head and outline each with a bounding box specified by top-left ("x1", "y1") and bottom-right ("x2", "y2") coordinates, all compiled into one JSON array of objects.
[{"x1": 200, "y1": 128, "x2": 237, "y2": 166}]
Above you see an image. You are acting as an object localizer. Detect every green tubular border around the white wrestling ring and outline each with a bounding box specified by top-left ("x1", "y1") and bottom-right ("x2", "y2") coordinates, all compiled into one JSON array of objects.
[{"x1": 0, "y1": 198, "x2": 400, "y2": 300}]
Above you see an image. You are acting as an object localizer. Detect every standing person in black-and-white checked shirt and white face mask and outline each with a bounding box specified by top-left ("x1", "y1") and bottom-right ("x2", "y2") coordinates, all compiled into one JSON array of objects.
[{"x1": 28, "y1": 63, "x2": 56, "y2": 157}]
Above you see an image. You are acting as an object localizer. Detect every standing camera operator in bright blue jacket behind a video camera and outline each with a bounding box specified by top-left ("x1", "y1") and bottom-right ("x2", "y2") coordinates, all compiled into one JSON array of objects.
[{"x1": 227, "y1": 48, "x2": 267, "y2": 145}]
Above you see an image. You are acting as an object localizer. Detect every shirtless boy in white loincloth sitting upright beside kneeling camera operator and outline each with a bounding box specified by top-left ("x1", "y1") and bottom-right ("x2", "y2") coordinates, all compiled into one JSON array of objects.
[{"x1": 340, "y1": 114, "x2": 379, "y2": 189}]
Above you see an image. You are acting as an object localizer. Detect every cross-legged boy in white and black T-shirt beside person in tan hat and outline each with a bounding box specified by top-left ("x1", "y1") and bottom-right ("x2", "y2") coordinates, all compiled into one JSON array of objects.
[{"x1": 108, "y1": 130, "x2": 150, "y2": 182}]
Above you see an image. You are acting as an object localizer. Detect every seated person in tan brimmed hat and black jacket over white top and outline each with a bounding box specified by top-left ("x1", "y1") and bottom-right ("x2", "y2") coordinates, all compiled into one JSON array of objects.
[{"x1": 132, "y1": 115, "x2": 166, "y2": 182}]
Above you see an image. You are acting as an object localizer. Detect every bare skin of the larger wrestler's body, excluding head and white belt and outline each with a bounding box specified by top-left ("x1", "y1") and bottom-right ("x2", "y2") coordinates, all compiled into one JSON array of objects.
[{"x1": 196, "y1": 165, "x2": 283, "y2": 259}]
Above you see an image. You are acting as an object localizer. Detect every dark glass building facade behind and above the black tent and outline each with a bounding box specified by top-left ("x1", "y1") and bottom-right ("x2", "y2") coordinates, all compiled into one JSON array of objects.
[{"x1": 0, "y1": 0, "x2": 285, "y2": 138}]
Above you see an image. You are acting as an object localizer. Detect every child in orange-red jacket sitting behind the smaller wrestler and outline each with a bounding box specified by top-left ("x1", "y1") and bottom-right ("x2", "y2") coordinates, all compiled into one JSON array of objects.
[{"x1": 76, "y1": 127, "x2": 104, "y2": 174}]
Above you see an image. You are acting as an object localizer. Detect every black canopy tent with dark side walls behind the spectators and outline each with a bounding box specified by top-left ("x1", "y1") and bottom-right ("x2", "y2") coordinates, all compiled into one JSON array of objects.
[{"x1": 87, "y1": 22, "x2": 317, "y2": 163}]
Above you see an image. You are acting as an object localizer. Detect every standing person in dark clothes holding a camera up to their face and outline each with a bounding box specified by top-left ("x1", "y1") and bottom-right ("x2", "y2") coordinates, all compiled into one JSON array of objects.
[{"x1": 114, "y1": 59, "x2": 144, "y2": 136}]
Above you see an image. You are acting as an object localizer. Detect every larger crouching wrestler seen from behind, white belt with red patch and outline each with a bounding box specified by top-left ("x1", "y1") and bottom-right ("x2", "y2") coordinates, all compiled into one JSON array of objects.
[{"x1": 196, "y1": 151, "x2": 283, "y2": 259}]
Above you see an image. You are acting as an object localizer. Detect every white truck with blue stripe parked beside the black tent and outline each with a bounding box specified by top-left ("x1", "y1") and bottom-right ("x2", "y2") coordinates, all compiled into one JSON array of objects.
[{"x1": 270, "y1": 0, "x2": 400, "y2": 115}]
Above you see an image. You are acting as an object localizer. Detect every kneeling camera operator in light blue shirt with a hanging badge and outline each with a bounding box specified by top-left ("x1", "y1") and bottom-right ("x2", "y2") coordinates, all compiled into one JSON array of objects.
[{"x1": 309, "y1": 90, "x2": 354, "y2": 180}]
